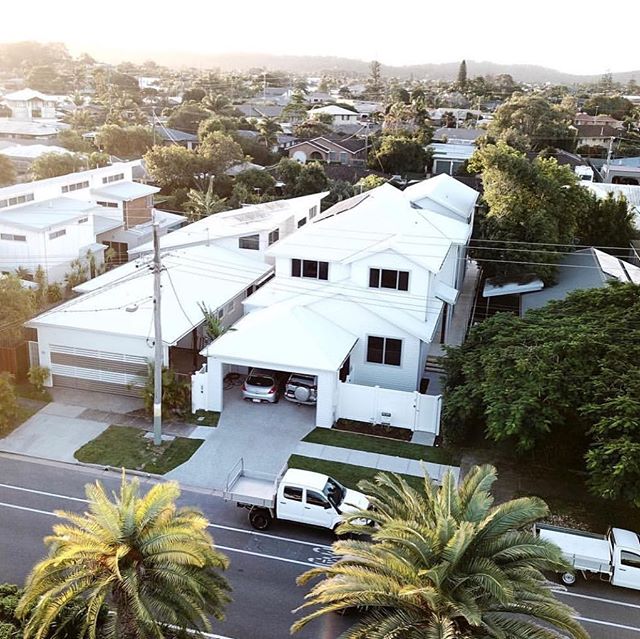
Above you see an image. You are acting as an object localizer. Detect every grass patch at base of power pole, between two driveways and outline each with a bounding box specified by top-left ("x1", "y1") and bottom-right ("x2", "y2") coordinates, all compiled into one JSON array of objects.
[{"x1": 74, "y1": 426, "x2": 204, "y2": 475}]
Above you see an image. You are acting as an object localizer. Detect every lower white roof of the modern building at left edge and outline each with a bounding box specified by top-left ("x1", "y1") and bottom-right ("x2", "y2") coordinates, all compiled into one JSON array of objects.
[{"x1": 0, "y1": 197, "x2": 100, "y2": 231}]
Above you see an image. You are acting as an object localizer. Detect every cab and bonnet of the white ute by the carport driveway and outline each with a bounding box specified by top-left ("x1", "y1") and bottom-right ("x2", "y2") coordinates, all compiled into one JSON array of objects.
[{"x1": 276, "y1": 468, "x2": 369, "y2": 530}]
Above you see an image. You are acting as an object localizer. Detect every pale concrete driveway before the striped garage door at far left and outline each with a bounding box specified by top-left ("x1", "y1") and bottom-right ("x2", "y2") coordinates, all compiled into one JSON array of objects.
[{"x1": 0, "y1": 402, "x2": 109, "y2": 462}]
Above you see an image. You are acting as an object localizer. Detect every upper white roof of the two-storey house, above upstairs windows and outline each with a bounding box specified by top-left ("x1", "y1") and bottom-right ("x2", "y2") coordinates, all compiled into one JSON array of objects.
[{"x1": 267, "y1": 184, "x2": 471, "y2": 273}]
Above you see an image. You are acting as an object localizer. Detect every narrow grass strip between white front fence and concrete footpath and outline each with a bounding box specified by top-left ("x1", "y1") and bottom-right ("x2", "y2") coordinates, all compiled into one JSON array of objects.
[{"x1": 302, "y1": 428, "x2": 460, "y2": 466}]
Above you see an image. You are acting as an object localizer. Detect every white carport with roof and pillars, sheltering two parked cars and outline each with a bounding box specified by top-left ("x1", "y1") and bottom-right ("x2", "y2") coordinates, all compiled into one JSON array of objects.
[{"x1": 192, "y1": 303, "x2": 358, "y2": 428}]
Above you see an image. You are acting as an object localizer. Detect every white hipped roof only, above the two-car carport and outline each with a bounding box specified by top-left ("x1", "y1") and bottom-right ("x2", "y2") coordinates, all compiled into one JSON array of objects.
[{"x1": 202, "y1": 303, "x2": 358, "y2": 371}]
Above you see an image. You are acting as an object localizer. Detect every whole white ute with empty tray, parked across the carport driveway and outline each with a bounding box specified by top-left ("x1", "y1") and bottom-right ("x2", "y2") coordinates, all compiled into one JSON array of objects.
[{"x1": 223, "y1": 459, "x2": 369, "y2": 530}]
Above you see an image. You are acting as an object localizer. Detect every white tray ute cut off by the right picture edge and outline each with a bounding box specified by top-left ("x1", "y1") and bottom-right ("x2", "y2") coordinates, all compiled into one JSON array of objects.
[{"x1": 536, "y1": 524, "x2": 640, "y2": 590}]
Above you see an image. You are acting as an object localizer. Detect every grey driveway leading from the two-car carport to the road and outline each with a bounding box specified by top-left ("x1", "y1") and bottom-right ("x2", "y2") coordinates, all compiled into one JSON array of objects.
[{"x1": 166, "y1": 388, "x2": 316, "y2": 490}]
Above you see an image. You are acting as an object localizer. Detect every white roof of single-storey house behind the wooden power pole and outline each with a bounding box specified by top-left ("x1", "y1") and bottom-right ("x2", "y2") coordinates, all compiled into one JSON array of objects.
[{"x1": 28, "y1": 246, "x2": 271, "y2": 344}]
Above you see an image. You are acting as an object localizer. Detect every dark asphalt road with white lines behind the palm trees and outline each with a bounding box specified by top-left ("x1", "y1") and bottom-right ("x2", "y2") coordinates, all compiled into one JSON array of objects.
[{"x1": 0, "y1": 454, "x2": 640, "y2": 639}]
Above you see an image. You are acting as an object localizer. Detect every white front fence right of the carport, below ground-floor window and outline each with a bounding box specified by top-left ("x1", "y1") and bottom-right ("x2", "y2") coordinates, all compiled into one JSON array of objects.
[{"x1": 336, "y1": 382, "x2": 442, "y2": 435}]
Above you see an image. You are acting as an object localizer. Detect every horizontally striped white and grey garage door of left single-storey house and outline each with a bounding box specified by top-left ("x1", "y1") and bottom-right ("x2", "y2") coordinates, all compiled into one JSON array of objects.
[{"x1": 50, "y1": 344, "x2": 147, "y2": 396}]
